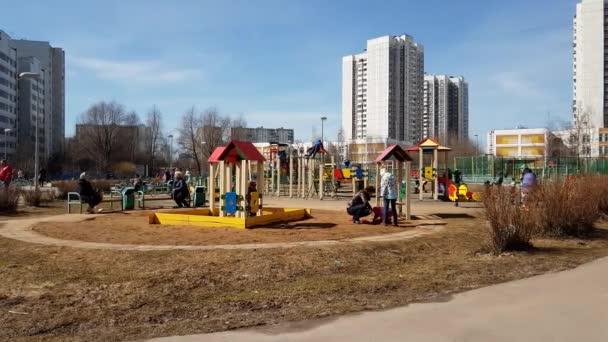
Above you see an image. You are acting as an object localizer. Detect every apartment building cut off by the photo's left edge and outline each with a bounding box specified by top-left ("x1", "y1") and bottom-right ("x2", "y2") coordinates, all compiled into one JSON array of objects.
[{"x1": 0, "y1": 30, "x2": 17, "y2": 158}]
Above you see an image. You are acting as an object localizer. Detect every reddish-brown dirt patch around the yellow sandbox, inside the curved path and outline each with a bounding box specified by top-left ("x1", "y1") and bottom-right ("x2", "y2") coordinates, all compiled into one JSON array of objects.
[{"x1": 34, "y1": 210, "x2": 412, "y2": 245}]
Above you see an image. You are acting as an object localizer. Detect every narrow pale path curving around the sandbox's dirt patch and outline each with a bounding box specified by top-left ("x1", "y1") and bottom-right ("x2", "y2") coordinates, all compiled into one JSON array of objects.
[{"x1": 0, "y1": 214, "x2": 443, "y2": 251}]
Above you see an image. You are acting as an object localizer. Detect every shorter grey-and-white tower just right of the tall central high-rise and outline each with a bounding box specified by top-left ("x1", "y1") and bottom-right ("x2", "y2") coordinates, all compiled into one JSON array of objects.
[{"x1": 422, "y1": 75, "x2": 469, "y2": 144}]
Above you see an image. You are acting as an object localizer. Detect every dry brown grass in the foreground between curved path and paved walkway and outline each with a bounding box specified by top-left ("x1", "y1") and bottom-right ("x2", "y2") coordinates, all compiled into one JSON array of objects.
[{"x1": 0, "y1": 219, "x2": 608, "y2": 341}]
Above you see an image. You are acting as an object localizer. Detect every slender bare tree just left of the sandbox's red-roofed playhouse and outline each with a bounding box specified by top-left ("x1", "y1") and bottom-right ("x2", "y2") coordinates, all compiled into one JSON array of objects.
[{"x1": 177, "y1": 106, "x2": 203, "y2": 175}]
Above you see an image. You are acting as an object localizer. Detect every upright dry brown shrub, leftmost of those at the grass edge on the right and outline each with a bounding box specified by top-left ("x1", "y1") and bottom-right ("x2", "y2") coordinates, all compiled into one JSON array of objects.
[{"x1": 483, "y1": 186, "x2": 535, "y2": 254}]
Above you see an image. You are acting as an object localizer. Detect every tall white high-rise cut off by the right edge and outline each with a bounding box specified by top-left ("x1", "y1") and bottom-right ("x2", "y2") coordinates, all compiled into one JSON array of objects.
[{"x1": 573, "y1": 0, "x2": 608, "y2": 128}]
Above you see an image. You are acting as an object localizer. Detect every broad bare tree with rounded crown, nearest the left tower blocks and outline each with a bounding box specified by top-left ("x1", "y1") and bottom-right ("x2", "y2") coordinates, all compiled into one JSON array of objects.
[{"x1": 76, "y1": 101, "x2": 132, "y2": 171}]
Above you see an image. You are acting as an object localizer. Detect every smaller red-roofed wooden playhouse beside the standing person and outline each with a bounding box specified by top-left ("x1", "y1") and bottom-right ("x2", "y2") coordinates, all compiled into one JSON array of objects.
[{"x1": 375, "y1": 145, "x2": 413, "y2": 220}]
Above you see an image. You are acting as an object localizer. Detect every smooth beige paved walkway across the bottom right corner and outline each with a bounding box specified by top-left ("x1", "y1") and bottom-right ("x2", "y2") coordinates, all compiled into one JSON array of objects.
[{"x1": 151, "y1": 259, "x2": 608, "y2": 342}]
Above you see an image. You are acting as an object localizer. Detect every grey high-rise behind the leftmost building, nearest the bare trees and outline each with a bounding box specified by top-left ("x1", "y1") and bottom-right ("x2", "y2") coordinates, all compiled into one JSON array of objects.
[{"x1": 11, "y1": 39, "x2": 65, "y2": 160}]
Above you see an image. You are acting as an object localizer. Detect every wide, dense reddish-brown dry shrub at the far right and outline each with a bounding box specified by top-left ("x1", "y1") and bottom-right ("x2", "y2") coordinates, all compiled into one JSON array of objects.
[{"x1": 528, "y1": 176, "x2": 608, "y2": 237}]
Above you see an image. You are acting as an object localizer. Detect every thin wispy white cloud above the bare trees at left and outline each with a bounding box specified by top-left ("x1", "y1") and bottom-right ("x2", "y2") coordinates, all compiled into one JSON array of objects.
[{"x1": 68, "y1": 56, "x2": 202, "y2": 85}]
